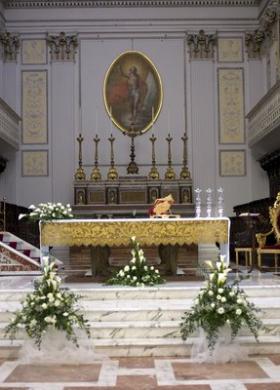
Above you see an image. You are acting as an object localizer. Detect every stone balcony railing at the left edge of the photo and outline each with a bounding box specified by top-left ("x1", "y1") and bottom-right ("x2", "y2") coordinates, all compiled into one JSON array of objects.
[{"x1": 0, "y1": 98, "x2": 21, "y2": 149}]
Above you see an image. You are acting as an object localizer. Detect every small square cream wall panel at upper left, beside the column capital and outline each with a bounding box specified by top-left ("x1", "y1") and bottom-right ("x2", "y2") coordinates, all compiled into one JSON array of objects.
[{"x1": 21, "y1": 39, "x2": 47, "y2": 65}]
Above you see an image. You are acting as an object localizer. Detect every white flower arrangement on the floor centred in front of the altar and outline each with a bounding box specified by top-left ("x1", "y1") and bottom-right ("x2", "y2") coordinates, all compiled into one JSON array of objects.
[{"x1": 107, "y1": 237, "x2": 165, "y2": 287}]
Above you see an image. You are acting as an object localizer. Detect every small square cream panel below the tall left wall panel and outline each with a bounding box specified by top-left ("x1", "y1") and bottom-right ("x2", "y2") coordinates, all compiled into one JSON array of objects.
[{"x1": 22, "y1": 150, "x2": 48, "y2": 176}]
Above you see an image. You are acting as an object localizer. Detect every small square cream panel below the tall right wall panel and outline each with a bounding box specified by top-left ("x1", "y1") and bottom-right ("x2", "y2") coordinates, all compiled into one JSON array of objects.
[{"x1": 220, "y1": 150, "x2": 246, "y2": 176}]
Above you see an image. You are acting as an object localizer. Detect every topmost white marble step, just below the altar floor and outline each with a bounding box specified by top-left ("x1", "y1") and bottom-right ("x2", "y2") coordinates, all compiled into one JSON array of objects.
[{"x1": 0, "y1": 282, "x2": 280, "y2": 305}]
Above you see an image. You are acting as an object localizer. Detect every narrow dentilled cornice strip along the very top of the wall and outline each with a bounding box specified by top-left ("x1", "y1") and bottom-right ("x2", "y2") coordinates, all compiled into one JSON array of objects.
[{"x1": 4, "y1": 0, "x2": 260, "y2": 8}]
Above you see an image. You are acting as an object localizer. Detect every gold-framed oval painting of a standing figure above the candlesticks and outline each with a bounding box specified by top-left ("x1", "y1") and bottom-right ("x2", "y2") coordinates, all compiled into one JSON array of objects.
[{"x1": 104, "y1": 51, "x2": 162, "y2": 136}]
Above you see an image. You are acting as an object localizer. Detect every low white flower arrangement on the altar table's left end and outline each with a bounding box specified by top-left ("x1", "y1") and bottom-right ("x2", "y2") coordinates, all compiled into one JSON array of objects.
[{"x1": 19, "y1": 202, "x2": 73, "y2": 221}]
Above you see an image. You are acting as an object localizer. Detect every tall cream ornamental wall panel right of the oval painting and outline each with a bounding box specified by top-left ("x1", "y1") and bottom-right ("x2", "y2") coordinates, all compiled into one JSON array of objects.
[{"x1": 218, "y1": 68, "x2": 245, "y2": 144}]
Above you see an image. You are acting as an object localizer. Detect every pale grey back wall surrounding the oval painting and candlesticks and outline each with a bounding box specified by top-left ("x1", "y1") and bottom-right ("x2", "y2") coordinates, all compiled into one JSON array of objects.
[{"x1": 0, "y1": 3, "x2": 268, "y2": 215}]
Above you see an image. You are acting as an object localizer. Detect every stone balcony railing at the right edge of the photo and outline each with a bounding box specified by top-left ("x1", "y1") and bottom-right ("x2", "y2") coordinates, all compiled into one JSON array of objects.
[{"x1": 247, "y1": 81, "x2": 280, "y2": 146}]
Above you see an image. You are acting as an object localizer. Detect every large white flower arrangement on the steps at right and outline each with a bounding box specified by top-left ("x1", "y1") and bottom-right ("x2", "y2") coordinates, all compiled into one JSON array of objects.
[{"x1": 181, "y1": 256, "x2": 262, "y2": 351}]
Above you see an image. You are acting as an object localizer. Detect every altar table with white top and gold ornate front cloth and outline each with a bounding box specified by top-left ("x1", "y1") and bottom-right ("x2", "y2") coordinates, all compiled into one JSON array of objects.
[{"x1": 40, "y1": 218, "x2": 230, "y2": 275}]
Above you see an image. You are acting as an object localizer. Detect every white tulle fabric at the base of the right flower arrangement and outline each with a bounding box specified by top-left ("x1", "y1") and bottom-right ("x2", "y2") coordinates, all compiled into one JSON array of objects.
[{"x1": 191, "y1": 326, "x2": 248, "y2": 363}]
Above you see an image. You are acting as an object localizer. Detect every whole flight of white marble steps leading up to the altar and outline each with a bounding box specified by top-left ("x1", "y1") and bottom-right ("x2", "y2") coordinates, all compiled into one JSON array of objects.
[{"x1": 0, "y1": 271, "x2": 280, "y2": 358}]
